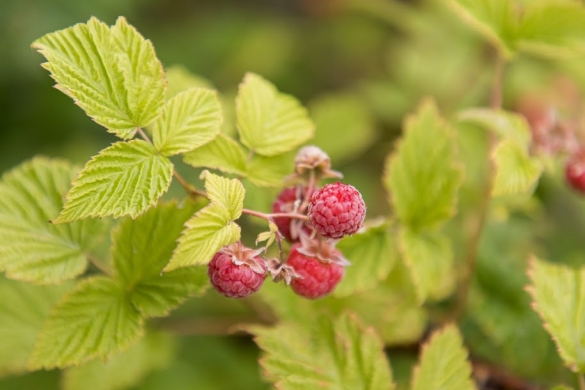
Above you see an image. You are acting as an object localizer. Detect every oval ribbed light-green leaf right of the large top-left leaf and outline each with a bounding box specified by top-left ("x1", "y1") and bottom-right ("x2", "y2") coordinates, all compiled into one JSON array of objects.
[{"x1": 153, "y1": 88, "x2": 222, "y2": 156}]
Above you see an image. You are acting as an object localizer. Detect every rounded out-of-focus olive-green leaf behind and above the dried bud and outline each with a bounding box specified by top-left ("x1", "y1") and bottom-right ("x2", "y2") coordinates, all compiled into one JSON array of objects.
[{"x1": 309, "y1": 94, "x2": 376, "y2": 162}]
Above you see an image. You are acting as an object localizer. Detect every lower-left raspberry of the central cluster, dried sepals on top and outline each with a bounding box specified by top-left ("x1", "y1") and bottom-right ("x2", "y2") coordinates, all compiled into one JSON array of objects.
[{"x1": 207, "y1": 243, "x2": 266, "y2": 298}]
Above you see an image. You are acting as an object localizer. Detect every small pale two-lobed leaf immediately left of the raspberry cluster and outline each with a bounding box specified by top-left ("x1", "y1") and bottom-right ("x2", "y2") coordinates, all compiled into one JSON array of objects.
[{"x1": 165, "y1": 171, "x2": 245, "y2": 272}]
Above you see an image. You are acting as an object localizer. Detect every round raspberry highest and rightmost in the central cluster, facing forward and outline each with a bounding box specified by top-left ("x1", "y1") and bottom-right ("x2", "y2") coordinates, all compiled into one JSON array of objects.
[{"x1": 309, "y1": 182, "x2": 366, "y2": 239}]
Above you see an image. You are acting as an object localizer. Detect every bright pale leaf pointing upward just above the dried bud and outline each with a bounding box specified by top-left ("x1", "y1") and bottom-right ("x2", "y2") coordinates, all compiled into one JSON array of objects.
[{"x1": 236, "y1": 73, "x2": 314, "y2": 156}]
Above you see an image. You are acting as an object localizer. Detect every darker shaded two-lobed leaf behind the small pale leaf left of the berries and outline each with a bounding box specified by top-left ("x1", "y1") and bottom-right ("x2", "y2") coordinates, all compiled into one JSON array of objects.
[{"x1": 111, "y1": 202, "x2": 209, "y2": 317}]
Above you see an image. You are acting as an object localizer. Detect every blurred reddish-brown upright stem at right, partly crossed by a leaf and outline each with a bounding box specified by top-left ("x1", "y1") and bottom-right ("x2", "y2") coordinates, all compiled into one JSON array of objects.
[{"x1": 452, "y1": 48, "x2": 502, "y2": 322}]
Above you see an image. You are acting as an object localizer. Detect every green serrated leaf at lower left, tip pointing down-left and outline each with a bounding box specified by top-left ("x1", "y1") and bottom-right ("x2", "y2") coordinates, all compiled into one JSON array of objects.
[{"x1": 29, "y1": 277, "x2": 144, "y2": 370}]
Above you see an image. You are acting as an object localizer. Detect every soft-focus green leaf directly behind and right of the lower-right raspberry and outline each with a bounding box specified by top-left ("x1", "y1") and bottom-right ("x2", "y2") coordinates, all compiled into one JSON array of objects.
[{"x1": 335, "y1": 223, "x2": 396, "y2": 297}]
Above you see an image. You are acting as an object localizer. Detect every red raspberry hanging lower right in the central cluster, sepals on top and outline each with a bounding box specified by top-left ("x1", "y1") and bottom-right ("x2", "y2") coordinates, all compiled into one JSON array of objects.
[{"x1": 286, "y1": 243, "x2": 344, "y2": 299}]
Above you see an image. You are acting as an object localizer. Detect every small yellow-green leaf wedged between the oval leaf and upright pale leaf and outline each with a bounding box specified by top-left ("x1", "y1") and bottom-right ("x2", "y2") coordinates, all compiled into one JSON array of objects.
[{"x1": 183, "y1": 134, "x2": 246, "y2": 175}]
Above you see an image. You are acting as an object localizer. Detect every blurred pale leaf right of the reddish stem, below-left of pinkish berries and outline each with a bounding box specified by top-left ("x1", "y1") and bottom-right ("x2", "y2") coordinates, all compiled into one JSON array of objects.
[{"x1": 492, "y1": 140, "x2": 543, "y2": 196}]
